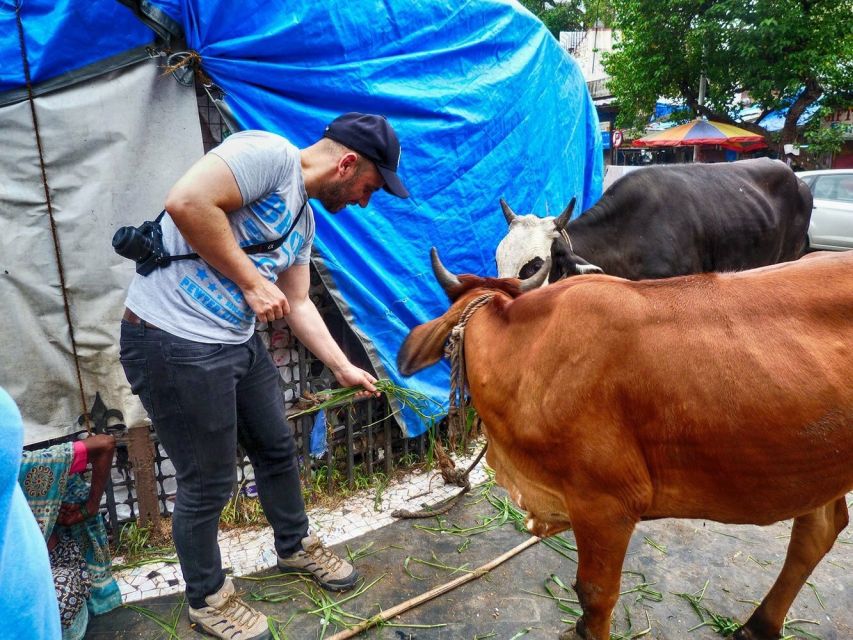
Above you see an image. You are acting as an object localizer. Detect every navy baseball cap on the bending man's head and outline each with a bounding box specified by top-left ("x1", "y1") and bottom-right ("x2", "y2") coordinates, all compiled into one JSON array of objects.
[{"x1": 323, "y1": 112, "x2": 409, "y2": 198}]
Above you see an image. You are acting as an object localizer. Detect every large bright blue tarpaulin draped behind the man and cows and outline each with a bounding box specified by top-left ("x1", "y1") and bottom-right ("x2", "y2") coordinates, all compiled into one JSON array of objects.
[{"x1": 0, "y1": 0, "x2": 603, "y2": 435}]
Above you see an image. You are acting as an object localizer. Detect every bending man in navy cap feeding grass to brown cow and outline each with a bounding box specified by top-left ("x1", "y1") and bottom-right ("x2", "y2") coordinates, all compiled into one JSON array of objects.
[{"x1": 121, "y1": 113, "x2": 409, "y2": 640}]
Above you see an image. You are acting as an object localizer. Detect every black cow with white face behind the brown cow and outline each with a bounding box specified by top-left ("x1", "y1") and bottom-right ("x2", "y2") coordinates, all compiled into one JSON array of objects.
[{"x1": 496, "y1": 158, "x2": 812, "y2": 282}]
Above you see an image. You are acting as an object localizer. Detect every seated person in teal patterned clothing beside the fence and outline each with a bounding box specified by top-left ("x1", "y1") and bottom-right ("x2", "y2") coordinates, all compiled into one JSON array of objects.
[{"x1": 18, "y1": 435, "x2": 121, "y2": 640}]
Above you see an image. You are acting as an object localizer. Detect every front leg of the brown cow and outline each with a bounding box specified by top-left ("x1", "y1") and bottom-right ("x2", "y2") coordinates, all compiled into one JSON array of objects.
[{"x1": 560, "y1": 503, "x2": 637, "y2": 640}]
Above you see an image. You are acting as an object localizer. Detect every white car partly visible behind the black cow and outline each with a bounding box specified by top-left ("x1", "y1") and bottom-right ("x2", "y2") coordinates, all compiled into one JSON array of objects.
[{"x1": 797, "y1": 169, "x2": 853, "y2": 251}]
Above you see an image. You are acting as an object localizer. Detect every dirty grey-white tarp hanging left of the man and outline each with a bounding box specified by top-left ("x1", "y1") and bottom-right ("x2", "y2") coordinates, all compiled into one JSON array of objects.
[{"x1": 0, "y1": 60, "x2": 203, "y2": 444}]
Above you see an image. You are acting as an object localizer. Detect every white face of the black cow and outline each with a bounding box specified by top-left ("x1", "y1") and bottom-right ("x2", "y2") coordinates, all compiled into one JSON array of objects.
[{"x1": 495, "y1": 214, "x2": 558, "y2": 284}]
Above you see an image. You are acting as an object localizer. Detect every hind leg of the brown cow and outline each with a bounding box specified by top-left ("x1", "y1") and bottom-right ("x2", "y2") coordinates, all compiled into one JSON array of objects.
[{"x1": 734, "y1": 496, "x2": 849, "y2": 640}]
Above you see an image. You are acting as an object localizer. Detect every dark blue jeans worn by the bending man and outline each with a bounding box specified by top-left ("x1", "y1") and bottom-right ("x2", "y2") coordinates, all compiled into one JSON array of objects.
[{"x1": 120, "y1": 320, "x2": 308, "y2": 609}]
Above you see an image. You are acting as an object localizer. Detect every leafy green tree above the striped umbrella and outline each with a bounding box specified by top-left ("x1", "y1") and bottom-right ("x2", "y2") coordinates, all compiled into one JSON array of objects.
[{"x1": 604, "y1": 0, "x2": 853, "y2": 147}]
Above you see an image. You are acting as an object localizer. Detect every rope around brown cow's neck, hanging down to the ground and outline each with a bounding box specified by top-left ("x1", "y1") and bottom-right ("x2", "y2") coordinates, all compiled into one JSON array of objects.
[{"x1": 391, "y1": 292, "x2": 495, "y2": 518}]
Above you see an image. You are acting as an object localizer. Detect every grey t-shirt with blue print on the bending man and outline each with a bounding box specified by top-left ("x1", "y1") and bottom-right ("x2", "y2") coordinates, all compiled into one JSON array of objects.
[{"x1": 126, "y1": 131, "x2": 314, "y2": 344}]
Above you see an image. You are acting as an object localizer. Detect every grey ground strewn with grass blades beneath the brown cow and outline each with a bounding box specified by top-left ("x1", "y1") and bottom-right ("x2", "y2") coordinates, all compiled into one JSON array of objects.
[{"x1": 86, "y1": 486, "x2": 853, "y2": 640}]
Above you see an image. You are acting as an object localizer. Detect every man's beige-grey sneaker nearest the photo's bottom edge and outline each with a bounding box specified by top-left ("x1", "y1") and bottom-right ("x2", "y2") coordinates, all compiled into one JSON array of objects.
[{"x1": 190, "y1": 578, "x2": 270, "y2": 640}]
